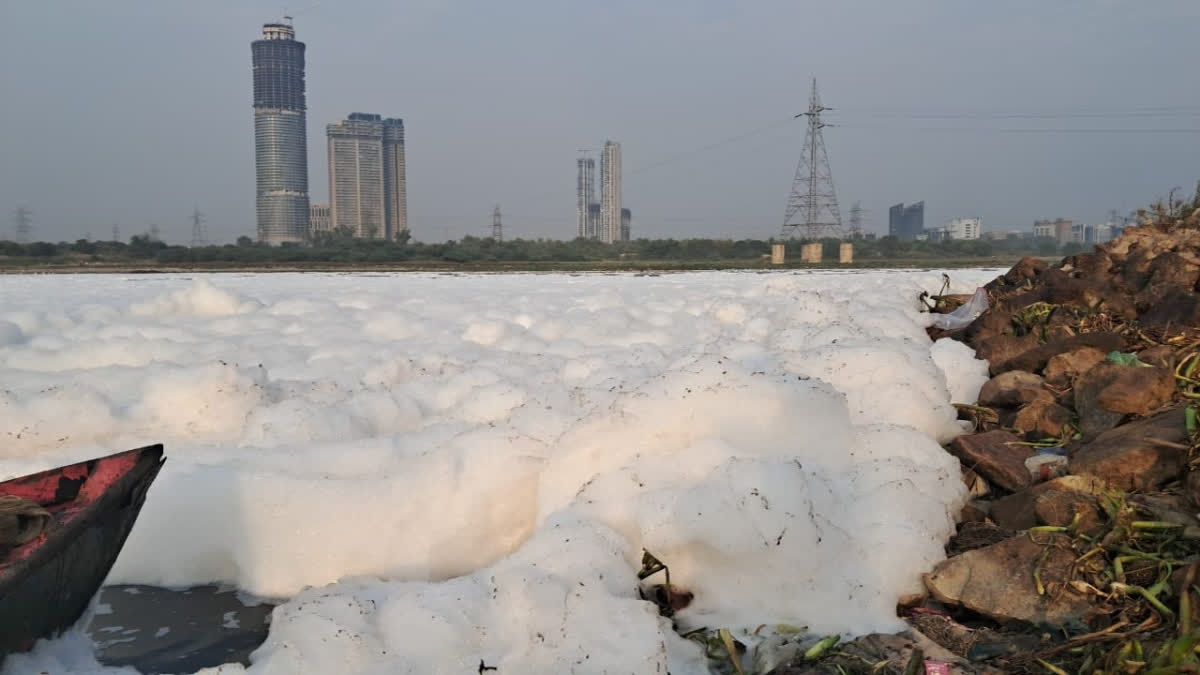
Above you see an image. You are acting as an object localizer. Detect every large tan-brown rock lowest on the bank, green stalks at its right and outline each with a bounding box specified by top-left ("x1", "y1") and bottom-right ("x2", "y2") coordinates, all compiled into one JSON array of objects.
[{"x1": 925, "y1": 534, "x2": 1093, "y2": 627}]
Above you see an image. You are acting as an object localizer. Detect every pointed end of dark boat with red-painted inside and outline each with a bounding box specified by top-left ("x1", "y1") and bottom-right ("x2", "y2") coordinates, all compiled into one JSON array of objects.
[{"x1": 0, "y1": 444, "x2": 163, "y2": 663}]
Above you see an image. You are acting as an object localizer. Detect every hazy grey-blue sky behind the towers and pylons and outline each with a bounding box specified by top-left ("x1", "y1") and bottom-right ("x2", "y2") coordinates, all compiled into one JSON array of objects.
[{"x1": 0, "y1": 0, "x2": 1200, "y2": 243}]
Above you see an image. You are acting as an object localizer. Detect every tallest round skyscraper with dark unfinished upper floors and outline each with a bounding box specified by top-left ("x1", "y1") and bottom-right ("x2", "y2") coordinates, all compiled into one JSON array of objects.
[{"x1": 250, "y1": 24, "x2": 308, "y2": 244}]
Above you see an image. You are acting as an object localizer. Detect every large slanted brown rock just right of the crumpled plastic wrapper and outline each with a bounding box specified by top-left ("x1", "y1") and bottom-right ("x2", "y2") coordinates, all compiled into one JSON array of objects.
[{"x1": 1069, "y1": 408, "x2": 1188, "y2": 490}]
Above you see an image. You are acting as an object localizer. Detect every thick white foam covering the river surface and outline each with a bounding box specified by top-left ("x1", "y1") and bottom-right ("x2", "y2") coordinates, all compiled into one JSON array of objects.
[{"x1": 0, "y1": 271, "x2": 995, "y2": 674}]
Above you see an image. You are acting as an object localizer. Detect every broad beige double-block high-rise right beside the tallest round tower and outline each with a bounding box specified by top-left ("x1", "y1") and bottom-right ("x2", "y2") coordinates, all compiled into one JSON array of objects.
[{"x1": 325, "y1": 113, "x2": 408, "y2": 239}]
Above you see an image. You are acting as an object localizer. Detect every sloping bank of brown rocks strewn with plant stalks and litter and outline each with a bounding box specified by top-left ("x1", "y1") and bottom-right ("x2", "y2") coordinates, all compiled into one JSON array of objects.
[{"x1": 775, "y1": 204, "x2": 1200, "y2": 675}]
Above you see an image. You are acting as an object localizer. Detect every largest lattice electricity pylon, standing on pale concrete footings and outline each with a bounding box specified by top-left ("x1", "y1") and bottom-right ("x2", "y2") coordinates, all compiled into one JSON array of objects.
[{"x1": 780, "y1": 78, "x2": 842, "y2": 239}]
